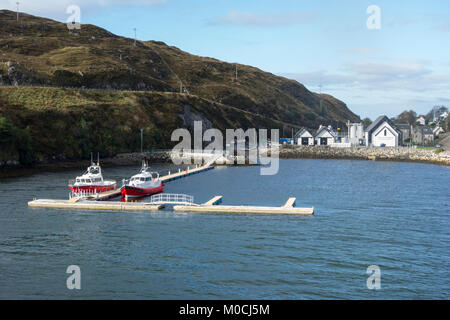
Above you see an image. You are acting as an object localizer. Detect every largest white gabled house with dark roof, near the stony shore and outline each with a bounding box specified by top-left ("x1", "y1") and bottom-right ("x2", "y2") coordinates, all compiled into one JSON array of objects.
[{"x1": 364, "y1": 115, "x2": 401, "y2": 147}]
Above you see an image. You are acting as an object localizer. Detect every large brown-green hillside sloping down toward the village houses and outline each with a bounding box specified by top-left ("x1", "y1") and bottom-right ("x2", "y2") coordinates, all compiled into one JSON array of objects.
[{"x1": 0, "y1": 10, "x2": 359, "y2": 165}]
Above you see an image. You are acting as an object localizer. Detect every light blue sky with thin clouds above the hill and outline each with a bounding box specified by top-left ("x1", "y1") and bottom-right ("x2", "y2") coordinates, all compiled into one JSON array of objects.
[{"x1": 0, "y1": 0, "x2": 450, "y2": 120}]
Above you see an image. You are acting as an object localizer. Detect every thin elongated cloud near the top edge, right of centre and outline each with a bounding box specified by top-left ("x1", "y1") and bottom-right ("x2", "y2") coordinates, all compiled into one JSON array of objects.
[{"x1": 211, "y1": 11, "x2": 315, "y2": 27}]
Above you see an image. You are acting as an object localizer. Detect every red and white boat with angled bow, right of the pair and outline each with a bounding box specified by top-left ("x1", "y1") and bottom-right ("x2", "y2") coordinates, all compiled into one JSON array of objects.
[{"x1": 120, "y1": 161, "x2": 164, "y2": 200}]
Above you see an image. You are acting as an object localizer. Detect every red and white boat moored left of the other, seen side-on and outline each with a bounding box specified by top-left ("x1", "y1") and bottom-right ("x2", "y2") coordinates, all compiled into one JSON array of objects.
[{"x1": 69, "y1": 160, "x2": 117, "y2": 194}]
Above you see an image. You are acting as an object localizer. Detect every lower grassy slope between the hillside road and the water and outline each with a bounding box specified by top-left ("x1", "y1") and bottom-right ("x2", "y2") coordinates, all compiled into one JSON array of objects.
[{"x1": 0, "y1": 87, "x2": 283, "y2": 164}]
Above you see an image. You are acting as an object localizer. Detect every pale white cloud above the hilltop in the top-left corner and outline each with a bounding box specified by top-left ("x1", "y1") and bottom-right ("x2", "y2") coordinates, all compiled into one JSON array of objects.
[{"x1": 0, "y1": 0, "x2": 168, "y2": 22}]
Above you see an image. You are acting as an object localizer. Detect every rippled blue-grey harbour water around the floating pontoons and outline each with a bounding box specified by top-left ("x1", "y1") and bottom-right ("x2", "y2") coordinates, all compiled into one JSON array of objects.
[{"x1": 0, "y1": 160, "x2": 450, "y2": 299}]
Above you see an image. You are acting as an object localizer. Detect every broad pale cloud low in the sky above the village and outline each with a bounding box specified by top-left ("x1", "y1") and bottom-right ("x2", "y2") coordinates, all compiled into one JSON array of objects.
[{"x1": 281, "y1": 61, "x2": 450, "y2": 118}]
